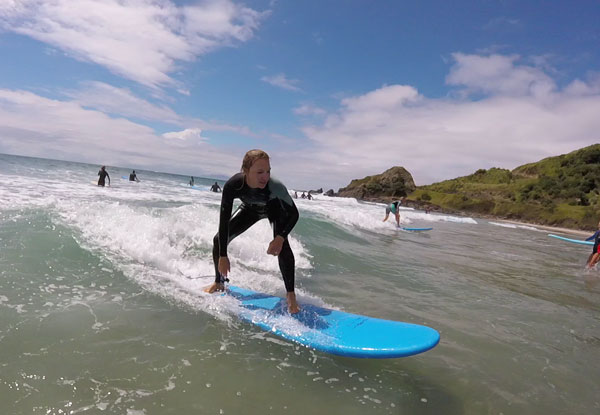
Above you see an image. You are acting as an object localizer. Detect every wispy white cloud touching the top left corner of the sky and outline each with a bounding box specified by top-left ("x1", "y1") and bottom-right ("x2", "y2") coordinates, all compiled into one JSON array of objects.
[{"x1": 0, "y1": 0, "x2": 267, "y2": 90}]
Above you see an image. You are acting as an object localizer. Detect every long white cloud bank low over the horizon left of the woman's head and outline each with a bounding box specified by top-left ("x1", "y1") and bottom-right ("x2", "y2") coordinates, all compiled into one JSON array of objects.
[{"x1": 0, "y1": 89, "x2": 244, "y2": 175}]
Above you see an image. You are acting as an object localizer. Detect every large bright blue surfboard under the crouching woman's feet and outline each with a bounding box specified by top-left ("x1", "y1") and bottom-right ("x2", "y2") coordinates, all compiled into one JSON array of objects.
[{"x1": 227, "y1": 285, "x2": 440, "y2": 359}]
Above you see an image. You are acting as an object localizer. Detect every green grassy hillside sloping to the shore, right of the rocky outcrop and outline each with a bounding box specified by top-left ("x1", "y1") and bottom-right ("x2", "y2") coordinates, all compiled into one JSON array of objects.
[{"x1": 409, "y1": 144, "x2": 600, "y2": 229}]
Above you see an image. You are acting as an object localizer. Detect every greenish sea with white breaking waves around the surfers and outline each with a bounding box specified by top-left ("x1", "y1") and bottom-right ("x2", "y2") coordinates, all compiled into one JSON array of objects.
[{"x1": 0, "y1": 155, "x2": 600, "y2": 415}]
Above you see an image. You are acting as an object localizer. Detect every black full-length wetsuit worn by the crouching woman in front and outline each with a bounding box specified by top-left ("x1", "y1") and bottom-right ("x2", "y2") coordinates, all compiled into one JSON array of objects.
[{"x1": 213, "y1": 173, "x2": 298, "y2": 292}]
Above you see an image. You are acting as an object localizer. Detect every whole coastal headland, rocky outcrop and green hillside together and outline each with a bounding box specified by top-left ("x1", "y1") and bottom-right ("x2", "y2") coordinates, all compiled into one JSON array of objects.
[{"x1": 328, "y1": 144, "x2": 600, "y2": 231}]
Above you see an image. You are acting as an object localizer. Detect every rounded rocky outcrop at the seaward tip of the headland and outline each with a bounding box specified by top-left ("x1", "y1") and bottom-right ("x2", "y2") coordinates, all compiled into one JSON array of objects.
[{"x1": 337, "y1": 166, "x2": 416, "y2": 199}]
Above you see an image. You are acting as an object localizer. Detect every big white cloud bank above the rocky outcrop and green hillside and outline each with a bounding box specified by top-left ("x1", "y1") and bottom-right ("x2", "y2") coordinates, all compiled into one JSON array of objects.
[{"x1": 290, "y1": 54, "x2": 600, "y2": 187}]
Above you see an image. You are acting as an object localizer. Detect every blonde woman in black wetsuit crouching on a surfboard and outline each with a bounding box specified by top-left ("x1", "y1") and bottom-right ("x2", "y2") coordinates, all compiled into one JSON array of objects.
[{"x1": 204, "y1": 150, "x2": 300, "y2": 314}]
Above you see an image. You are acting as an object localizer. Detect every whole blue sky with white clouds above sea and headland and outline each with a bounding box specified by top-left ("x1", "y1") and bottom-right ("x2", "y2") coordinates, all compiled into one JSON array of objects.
[{"x1": 0, "y1": 0, "x2": 600, "y2": 191}]
